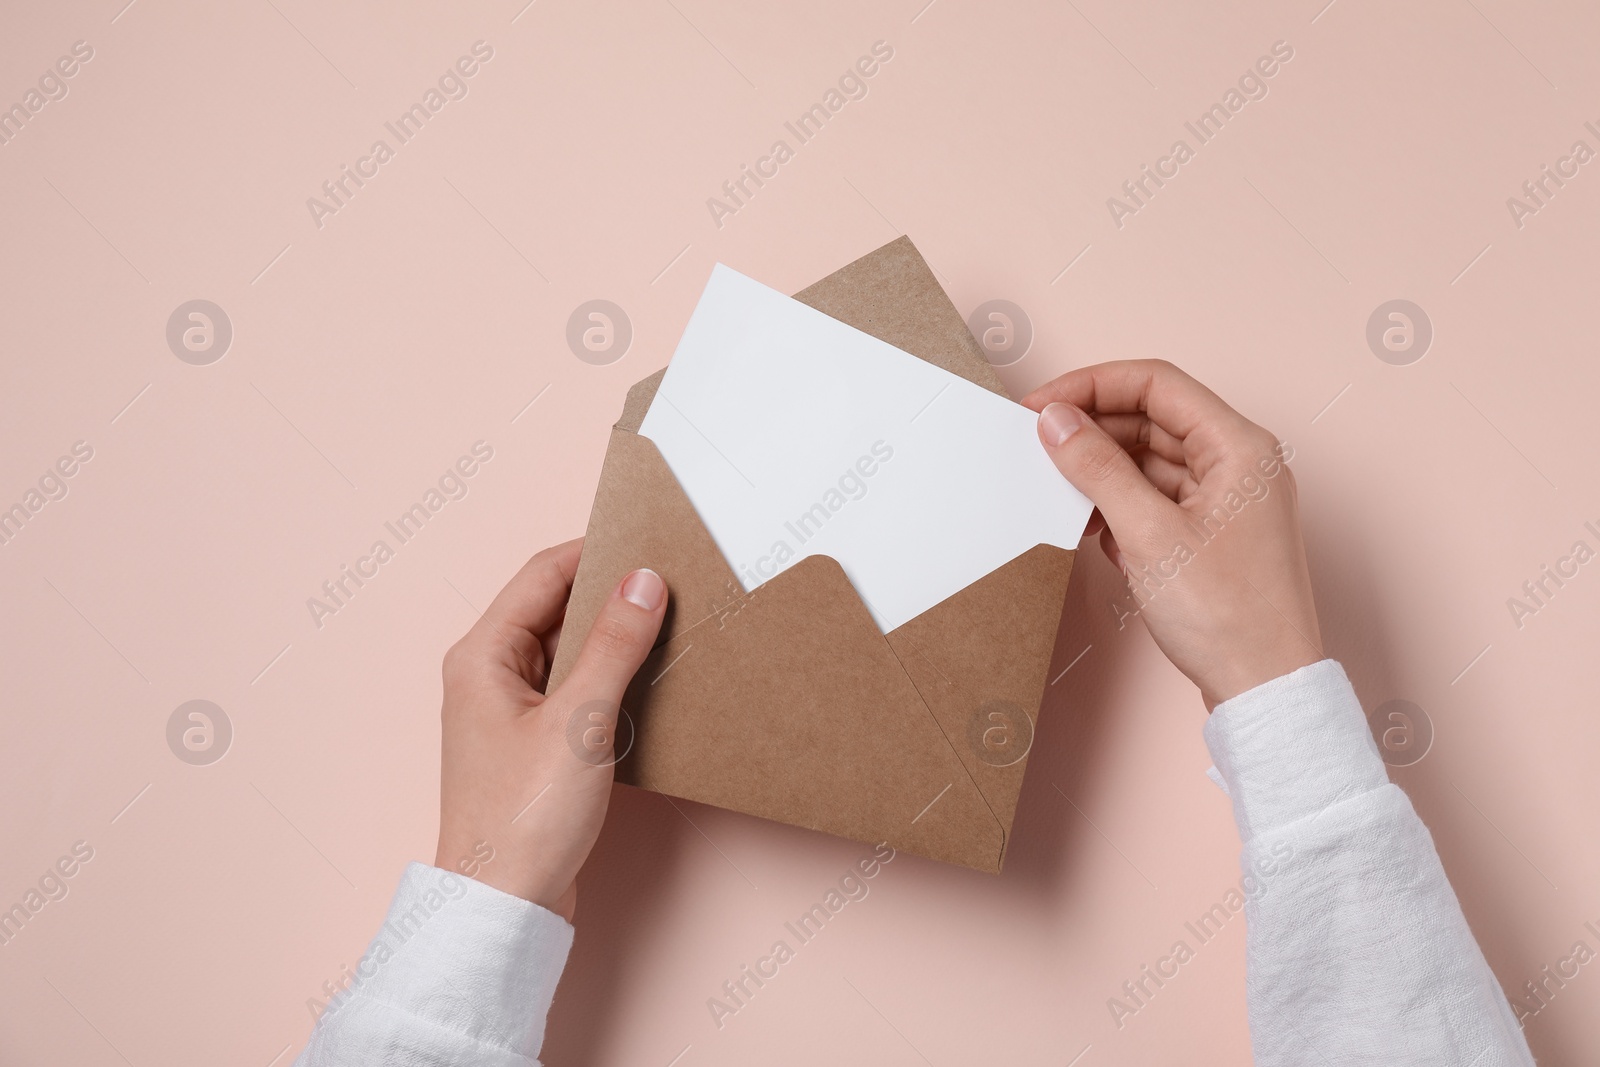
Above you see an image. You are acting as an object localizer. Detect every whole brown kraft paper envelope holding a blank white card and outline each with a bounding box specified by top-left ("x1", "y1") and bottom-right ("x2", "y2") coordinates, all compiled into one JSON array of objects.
[{"x1": 550, "y1": 237, "x2": 1074, "y2": 873}]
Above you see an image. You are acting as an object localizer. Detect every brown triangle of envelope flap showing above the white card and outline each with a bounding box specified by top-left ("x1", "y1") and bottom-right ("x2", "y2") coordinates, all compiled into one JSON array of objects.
[{"x1": 795, "y1": 237, "x2": 1006, "y2": 397}]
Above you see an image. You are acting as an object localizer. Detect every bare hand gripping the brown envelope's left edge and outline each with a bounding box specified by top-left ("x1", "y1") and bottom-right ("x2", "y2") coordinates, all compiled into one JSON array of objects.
[{"x1": 434, "y1": 541, "x2": 667, "y2": 921}]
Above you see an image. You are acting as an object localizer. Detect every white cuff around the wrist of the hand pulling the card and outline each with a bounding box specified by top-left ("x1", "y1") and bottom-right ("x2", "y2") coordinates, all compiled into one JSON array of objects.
[{"x1": 1205, "y1": 659, "x2": 1389, "y2": 841}]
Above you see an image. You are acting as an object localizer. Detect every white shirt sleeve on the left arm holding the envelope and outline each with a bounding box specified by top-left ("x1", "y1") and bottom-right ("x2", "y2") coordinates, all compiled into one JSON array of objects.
[{"x1": 294, "y1": 864, "x2": 573, "y2": 1067}]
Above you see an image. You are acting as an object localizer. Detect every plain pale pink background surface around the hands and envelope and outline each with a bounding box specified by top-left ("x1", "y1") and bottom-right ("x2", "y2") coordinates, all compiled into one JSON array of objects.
[{"x1": 0, "y1": 0, "x2": 1600, "y2": 1067}]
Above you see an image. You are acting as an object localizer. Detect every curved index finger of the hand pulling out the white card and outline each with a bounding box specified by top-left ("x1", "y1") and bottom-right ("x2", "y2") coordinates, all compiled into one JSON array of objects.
[{"x1": 1022, "y1": 360, "x2": 1254, "y2": 477}]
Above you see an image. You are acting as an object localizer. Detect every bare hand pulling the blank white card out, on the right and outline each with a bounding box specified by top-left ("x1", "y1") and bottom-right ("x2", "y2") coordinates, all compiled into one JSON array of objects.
[{"x1": 1022, "y1": 360, "x2": 1323, "y2": 709}]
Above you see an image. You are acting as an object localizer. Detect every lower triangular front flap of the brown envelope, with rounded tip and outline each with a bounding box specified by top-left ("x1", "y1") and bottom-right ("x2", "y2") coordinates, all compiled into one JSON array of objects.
[{"x1": 616, "y1": 555, "x2": 1005, "y2": 872}]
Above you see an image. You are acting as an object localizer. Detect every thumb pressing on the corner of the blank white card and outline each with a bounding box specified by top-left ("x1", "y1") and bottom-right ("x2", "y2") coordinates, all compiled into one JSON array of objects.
[{"x1": 1038, "y1": 402, "x2": 1173, "y2": 537}]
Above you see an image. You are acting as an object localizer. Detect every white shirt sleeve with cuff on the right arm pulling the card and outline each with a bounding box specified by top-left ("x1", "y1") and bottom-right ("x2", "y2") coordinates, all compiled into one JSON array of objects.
[{"x1": 1205, "y1": 659, "x2": 1533, "y2": 1067}]
